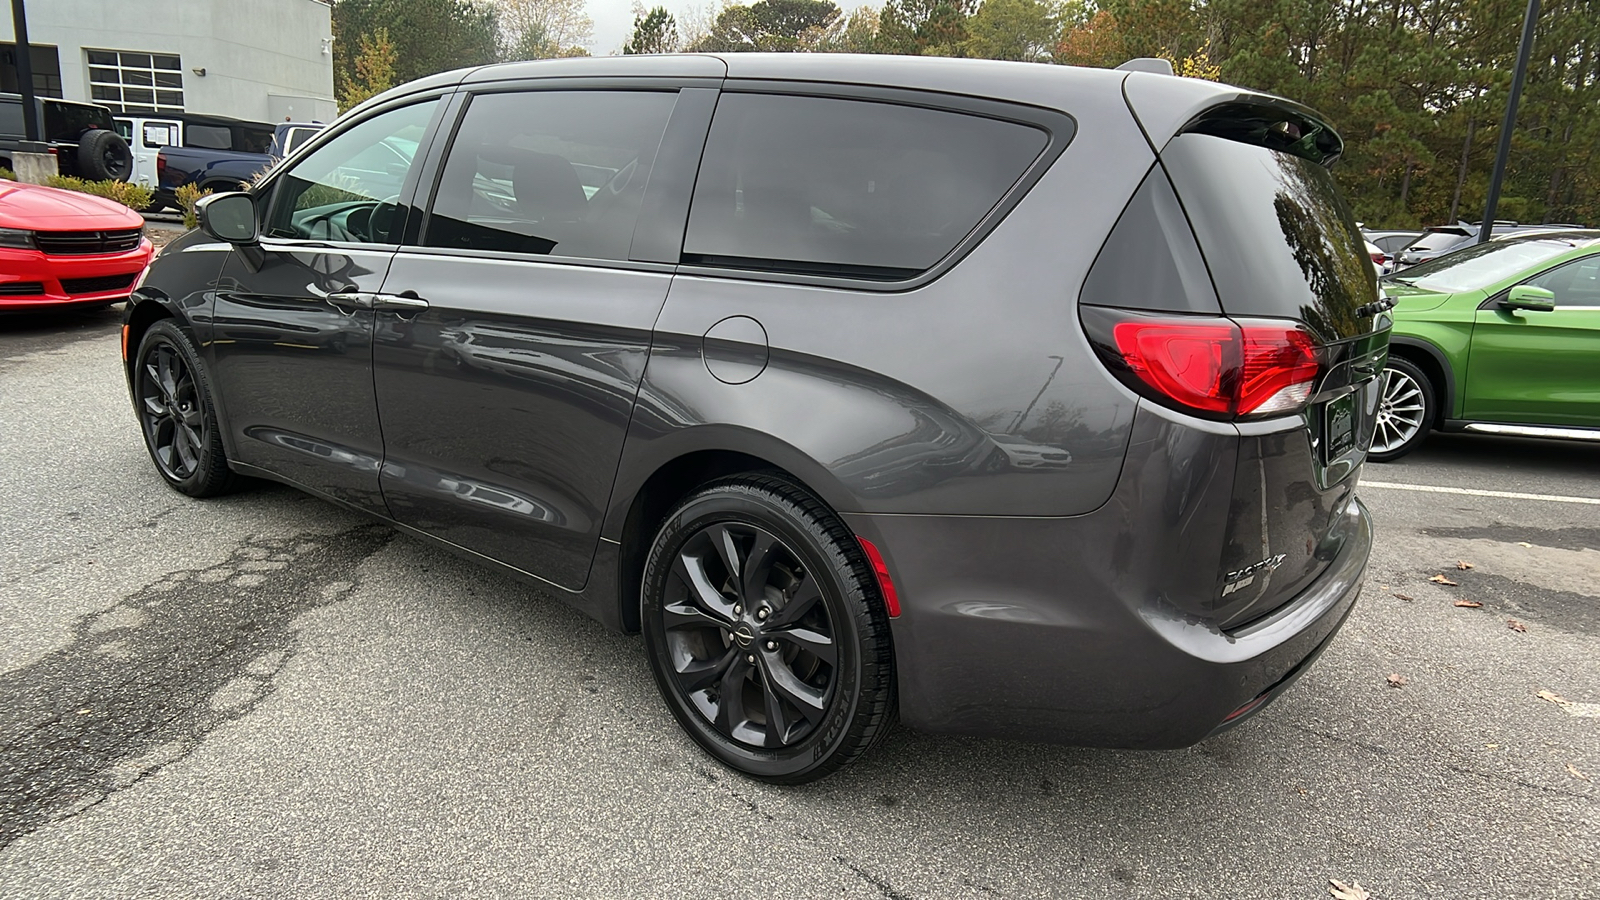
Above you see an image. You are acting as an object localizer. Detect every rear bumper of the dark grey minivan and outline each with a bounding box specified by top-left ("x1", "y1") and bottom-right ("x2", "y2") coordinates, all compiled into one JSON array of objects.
[{"x1": 846, "y1": 498, "x2": 1373, "y2": 749}]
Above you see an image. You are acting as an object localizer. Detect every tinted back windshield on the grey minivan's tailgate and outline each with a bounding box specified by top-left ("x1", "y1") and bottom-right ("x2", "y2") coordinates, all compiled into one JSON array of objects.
[{"x1": 1162, "y1": 135, "x2": 1378, "y2": 341}]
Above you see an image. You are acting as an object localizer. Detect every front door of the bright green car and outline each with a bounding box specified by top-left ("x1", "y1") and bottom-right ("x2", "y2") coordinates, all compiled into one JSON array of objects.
[{"x1": 1466, "y1": 253, "x2": 1600, "y2": 428}]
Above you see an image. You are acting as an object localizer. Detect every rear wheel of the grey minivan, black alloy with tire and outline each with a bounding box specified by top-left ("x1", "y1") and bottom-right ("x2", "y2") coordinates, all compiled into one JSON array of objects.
[{"x1": 642, "y1": 476, "x2": 894, "y2": 783}]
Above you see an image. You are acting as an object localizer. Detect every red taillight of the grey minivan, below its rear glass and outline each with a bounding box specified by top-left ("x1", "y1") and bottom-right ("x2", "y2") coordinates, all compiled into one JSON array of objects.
[{"x1": 1110, "y1": 315, "x2": 1322, "y2": 416}]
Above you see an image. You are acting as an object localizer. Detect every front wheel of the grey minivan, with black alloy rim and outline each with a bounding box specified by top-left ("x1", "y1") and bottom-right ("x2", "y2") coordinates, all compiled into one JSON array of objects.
[{"x1": 133, "y1": 319, "x2": 235, "y2": 496}]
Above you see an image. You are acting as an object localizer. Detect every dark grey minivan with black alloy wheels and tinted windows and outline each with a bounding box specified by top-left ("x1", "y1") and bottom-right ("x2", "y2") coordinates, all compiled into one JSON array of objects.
[{"x1": 125, "y1": 54, "x2": 1389, "y2": 781}]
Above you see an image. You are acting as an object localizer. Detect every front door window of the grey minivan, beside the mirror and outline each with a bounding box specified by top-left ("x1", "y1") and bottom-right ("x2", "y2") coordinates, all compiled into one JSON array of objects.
[{"x1": 264, "y1": 99, "x2": 438, "y2": 243}]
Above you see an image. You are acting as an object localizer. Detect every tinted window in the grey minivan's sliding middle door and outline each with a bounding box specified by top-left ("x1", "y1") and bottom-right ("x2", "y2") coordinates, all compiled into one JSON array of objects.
[{"x1": 422, "y1": 91, "x2": 677, "y2": 259}]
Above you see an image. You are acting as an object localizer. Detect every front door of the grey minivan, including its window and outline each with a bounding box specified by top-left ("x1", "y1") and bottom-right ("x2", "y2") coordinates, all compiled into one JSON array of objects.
[{"x1": 210, "y1": 99, "x2": 438, "y2": 512}]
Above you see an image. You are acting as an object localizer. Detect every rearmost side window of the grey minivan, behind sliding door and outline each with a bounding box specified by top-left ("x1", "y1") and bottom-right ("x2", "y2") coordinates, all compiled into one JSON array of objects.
[{"x1": 683, "y1": 93, "x2": 1050, "y2": 280}]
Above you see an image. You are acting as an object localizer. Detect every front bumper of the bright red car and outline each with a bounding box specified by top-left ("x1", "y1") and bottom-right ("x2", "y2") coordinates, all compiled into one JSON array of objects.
[{"x1": 0, "y1": 240, "x2": 154, "y2": 312}]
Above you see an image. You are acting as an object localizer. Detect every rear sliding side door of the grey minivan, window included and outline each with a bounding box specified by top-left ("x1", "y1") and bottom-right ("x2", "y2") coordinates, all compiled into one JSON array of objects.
[{"x1": 373, "y1": 90, "x2": 712, "y2": 589}]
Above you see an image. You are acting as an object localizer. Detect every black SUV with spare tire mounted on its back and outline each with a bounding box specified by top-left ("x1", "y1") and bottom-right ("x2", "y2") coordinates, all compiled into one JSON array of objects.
[{"x1": 0, "y1": 94, "x2": 133, "y2": 181}]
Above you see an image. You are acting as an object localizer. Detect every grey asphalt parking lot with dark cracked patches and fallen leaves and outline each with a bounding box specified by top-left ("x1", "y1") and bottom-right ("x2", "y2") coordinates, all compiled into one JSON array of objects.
[{"x1": 0, "y1": 311, "x2": 1600, "y2": 900}]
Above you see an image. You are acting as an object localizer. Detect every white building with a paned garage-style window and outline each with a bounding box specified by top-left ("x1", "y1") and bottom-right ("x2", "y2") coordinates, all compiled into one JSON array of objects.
[{"x1": 0, "y1": 0, "x2": 338, "y2": 122}]
